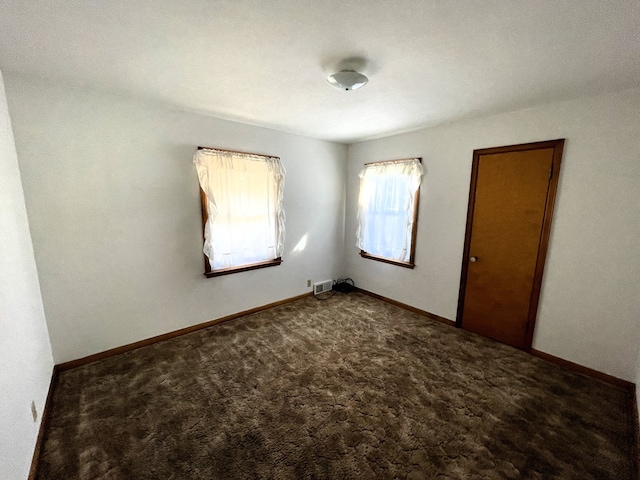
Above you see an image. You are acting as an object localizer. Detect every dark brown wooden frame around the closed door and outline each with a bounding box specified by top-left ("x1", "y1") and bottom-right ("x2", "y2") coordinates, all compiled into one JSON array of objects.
[{"x1": 456, "y1": 138, "x2": 564, "y2": 352}]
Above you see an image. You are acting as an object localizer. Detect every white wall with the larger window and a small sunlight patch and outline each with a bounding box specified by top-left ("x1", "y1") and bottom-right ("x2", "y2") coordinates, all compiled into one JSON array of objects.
[{"x1": 6, "y1": 75, "x2": 346, "y2": 363}]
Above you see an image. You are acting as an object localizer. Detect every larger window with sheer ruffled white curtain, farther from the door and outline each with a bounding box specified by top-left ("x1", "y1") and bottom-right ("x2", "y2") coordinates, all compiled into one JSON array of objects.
[{"x1": 193, "y1": 147, "x2": 285, "y2": 277}]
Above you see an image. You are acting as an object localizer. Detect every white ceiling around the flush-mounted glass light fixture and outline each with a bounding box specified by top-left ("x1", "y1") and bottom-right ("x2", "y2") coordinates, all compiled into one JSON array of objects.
[{"x1": 0, "y1": 0, "x2": 640, "y2": 143}]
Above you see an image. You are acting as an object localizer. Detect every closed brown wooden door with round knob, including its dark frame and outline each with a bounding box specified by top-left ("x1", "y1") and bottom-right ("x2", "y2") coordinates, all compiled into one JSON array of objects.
[{"x1": 456, "y1": 140, "x2": 564, "y2": 351}]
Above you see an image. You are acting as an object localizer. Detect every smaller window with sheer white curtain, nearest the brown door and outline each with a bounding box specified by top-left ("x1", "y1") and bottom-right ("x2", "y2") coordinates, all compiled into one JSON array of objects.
[{"x1": 356, "y1": 158, "x2": 423, "y2": 268}]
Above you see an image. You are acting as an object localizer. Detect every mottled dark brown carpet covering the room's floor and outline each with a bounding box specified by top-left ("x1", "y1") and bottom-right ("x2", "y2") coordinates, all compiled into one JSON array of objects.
[{"x1": 38, "y1": 293, "x2": 635, "y2": 480}]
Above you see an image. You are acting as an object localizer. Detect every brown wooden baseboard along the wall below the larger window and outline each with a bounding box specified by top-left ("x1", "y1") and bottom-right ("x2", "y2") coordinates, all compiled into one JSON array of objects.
[{"x1": 56, "y1": 292, "x2": 313, "y2": 372}]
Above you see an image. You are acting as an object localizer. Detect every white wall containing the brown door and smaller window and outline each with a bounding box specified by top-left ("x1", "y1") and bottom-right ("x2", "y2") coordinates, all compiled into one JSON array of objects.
[{"x1": 345, "y1": 90, "x2": 640, "y2": 381}]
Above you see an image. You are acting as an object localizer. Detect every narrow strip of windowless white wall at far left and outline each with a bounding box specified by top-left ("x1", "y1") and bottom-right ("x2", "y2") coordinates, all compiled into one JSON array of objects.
[{"x1": 0, "y1": 69, "x2": 53, "y2": 479}]
